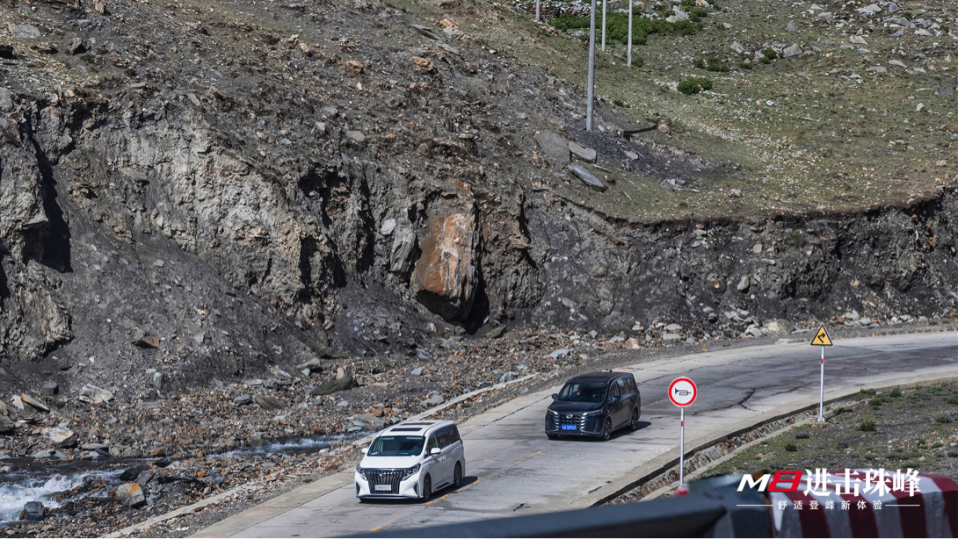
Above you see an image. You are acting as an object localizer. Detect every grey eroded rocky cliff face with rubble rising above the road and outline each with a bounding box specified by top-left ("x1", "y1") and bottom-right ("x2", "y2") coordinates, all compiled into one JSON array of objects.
[{"x1": 0, "y1": 3, "x2": 958, "y2": 394}]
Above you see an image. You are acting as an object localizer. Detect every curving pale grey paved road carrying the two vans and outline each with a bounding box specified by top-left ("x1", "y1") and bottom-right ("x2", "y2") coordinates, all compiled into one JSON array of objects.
[{"x1": 193, "y1": 333, "x2": 958, "y2": 539}]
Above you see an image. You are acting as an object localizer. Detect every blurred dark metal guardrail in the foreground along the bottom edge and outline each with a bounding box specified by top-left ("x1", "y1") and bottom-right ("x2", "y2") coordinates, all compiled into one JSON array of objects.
[{"x1": 340, "y1": 491, "x2": 772, "y2": 539}]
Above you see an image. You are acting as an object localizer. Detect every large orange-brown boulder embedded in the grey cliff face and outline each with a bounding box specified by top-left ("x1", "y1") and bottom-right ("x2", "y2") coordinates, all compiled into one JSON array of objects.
[{"x1": 410, "y1": 212, "x2": 480, "y2": 320}]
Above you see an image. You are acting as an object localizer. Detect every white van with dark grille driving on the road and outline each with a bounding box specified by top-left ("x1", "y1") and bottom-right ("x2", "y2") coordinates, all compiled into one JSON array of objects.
[{"x1": 355, "y1": 421, "x2": 466, "y2": 501}]
